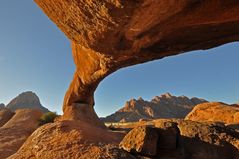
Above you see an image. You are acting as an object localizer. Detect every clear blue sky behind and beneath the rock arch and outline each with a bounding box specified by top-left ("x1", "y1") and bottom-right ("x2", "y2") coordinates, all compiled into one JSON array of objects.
[{"x1": 0, "y1": 0, "x2": 239, "y2": 116}]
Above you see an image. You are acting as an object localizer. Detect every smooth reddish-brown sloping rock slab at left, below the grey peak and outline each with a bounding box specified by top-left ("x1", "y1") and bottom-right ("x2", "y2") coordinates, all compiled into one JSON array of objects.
[{"x1": 0, "y1": 109, "x2": 42, "y2": 159}]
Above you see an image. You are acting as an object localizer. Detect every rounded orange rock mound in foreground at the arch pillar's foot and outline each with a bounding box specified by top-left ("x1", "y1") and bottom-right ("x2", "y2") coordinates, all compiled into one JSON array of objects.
[{"x1": 10, "y1": 120, "x2": 131, "y2": 159}]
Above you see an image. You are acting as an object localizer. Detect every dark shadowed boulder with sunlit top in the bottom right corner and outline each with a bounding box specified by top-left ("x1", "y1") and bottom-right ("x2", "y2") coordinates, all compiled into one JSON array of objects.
[{"x1": 170, "y1": 121, "x2": 239, "y2": 159}]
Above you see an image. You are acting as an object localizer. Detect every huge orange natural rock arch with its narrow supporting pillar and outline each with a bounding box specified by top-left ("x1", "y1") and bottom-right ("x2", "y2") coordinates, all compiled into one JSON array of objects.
[{"x1": 35, "y1": 0, "x2": 239, "y2": 126}]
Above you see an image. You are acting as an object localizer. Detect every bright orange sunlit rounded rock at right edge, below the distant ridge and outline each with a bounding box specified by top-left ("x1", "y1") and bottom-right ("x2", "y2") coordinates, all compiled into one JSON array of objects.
[{"x1": 185, "y1": 102, "x2": 239, "y2": 124}]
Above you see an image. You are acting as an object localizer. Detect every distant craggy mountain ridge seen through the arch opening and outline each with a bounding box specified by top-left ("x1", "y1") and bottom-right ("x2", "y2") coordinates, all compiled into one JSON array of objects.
[{"x1": 101, "y1": 93, "x2": 207, "y2": 122}]
